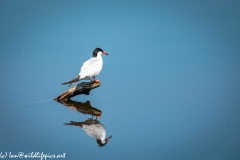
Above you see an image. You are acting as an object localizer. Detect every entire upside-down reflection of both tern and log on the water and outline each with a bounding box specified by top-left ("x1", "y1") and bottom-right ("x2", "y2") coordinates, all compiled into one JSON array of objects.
[{"x1": 58, "y1": 100, "x2": 112, "y2": 147}]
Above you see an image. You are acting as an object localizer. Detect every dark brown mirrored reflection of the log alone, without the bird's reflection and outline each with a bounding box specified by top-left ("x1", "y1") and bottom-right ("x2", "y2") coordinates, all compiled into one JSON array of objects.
[{"x1": 57, "y1": 100, "x2": 102, "y2": 117}]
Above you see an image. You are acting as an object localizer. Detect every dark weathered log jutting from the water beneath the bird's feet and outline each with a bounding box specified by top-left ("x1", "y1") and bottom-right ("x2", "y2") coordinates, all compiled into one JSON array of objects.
[{"x1": 55, "y1": 82, "x2": 101, "y2": 100}]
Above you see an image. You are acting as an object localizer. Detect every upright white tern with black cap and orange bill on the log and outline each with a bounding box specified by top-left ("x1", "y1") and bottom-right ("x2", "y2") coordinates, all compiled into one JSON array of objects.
[{"x1": 62, "y1": 48, "x2": 108, "y2": 86}]
